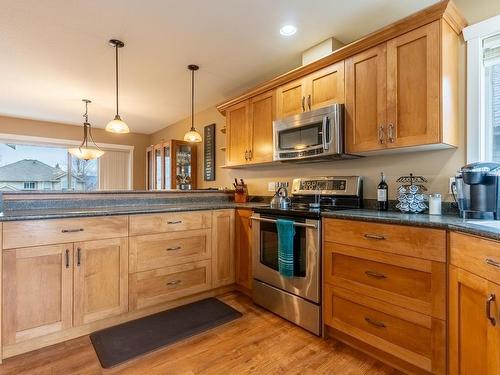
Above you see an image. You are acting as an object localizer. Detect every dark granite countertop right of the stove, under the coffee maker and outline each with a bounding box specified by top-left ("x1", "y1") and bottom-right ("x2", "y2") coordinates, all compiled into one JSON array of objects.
[{"x1": 322, "y1": 209, "x2": 500, "y2": 240}]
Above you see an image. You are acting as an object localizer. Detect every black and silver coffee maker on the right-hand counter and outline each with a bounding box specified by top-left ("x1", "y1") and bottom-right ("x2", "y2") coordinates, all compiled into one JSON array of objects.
[{"x1": 452, "y1": 163, "x2": 500, "y2": 220}]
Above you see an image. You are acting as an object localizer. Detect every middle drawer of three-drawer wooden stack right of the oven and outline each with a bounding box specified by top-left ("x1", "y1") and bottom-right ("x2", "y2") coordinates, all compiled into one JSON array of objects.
[{"x1": 323, "y1": 242, "x2": 446, "y2": 319}]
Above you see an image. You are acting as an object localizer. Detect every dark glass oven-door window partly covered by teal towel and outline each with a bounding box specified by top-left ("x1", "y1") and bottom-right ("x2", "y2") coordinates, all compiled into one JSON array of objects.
[{"x1": 260, "y1": 222, "x2": 306, "y2": 277}]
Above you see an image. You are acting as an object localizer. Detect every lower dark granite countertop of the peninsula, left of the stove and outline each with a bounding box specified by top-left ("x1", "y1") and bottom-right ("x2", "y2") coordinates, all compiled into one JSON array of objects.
[{"x1": 0, "y1": 201, "x2": 267, "y2": 221}]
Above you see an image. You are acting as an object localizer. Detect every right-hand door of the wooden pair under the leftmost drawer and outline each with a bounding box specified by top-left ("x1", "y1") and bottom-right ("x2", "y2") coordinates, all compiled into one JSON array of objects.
[{"x1": 74, "y1": 238, "x2": 128, "y2": 326}]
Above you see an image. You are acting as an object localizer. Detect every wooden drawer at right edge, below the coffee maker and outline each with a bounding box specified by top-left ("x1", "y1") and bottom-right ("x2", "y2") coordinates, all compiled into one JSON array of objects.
[{"x1": 450, "y1": 232, "x2": 500, "y2": 284}]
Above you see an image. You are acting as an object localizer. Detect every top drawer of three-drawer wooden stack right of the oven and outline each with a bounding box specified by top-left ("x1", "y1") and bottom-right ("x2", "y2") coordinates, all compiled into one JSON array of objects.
[{"x1": 324, "y1": 219, "x2": 446, "y2": 262}]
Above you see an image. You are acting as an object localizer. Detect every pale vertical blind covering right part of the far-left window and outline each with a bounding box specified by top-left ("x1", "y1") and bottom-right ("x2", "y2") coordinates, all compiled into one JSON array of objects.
[{"x1": 99, "y1": 150, "x2": 131, "y2": 190}]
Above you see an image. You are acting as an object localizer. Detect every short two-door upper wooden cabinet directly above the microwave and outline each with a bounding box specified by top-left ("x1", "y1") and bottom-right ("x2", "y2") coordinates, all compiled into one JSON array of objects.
[{"x1": 276, "y1": 61, "x2": 344, "y2": 118}]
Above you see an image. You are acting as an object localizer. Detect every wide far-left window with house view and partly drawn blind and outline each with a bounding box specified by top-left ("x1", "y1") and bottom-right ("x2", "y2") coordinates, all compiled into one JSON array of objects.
[{"x1": 0, "y1": 134, "x2": 131, "y2": 191}]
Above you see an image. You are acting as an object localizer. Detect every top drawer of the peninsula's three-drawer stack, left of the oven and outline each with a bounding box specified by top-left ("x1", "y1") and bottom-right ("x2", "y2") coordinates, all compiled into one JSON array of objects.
[{"x1": 130, "y1": 211, "x2": 212, "y2": 236}]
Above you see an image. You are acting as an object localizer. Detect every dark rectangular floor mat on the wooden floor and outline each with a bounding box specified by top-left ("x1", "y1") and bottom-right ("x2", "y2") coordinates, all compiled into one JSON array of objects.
[{"x1": 90, "y1": 298, "x2": 242, "y2": 368}]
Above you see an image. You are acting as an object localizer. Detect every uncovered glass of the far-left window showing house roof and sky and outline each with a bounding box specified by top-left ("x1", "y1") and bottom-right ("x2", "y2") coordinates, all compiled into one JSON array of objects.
[{"x1": 0, "y1": 143, "x2": 99, "y2": 191}]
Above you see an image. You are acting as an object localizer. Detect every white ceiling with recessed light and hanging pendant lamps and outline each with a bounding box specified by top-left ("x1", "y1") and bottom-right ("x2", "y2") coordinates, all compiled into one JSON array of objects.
[{"x1": 0, "y1": 0, "x2": 437, "y2": 134}]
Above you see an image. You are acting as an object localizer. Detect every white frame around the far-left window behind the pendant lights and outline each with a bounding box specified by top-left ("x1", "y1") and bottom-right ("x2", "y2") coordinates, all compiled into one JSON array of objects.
[{"x1": 0, "y1": 133, "x2": 135, "y2": 190}]
